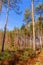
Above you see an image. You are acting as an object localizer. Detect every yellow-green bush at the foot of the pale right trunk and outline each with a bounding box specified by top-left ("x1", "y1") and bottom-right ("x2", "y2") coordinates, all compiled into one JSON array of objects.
[{"x1": 20, "y1": 48, "x2": 36, "y2": 60}]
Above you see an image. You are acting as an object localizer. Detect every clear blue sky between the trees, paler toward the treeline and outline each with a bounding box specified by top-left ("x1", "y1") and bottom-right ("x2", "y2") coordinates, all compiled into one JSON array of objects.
[{"x1": 0, "y1": 0, "x2": 42, "y2": 30}]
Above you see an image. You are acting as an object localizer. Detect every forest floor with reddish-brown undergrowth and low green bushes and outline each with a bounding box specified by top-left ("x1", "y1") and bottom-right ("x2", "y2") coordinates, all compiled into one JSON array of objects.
[{"x1": 0, "y1": 49, "x2": 43, "y2": 65}]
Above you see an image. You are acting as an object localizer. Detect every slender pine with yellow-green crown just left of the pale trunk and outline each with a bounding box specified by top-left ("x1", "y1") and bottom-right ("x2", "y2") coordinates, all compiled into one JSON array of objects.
[{"x1": 24, "y1": 9, "x2": 31, "y2": 47}]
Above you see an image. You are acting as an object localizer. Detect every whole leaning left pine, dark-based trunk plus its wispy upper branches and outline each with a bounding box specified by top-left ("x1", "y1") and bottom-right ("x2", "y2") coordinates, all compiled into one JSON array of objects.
[{"x1": 0, "y1": 0, "x2": 21, "y2": 52}]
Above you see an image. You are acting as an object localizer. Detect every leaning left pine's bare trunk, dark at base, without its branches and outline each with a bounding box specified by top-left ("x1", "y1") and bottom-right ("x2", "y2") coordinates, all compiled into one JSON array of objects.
[{"x1": 2, "y1": 0, "x2": 10, "y2": 52}]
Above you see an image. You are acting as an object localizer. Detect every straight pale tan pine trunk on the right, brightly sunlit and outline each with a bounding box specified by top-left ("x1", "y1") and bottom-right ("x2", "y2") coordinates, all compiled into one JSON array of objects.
[{"x1": 32, "y1": 0, "x2": 35, "y2": 50}]
